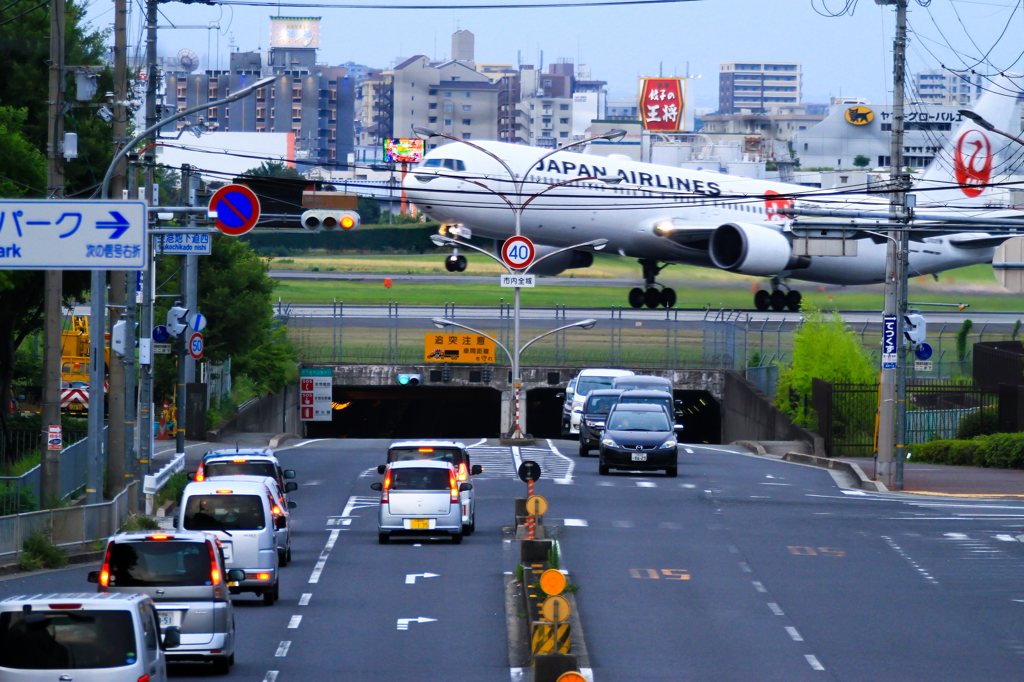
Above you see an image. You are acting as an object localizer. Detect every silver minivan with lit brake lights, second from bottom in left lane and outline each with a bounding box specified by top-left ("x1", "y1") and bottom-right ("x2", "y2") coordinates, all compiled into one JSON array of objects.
[{"x1": 88, "y1": 530, "x2": 246, "y2": 674}]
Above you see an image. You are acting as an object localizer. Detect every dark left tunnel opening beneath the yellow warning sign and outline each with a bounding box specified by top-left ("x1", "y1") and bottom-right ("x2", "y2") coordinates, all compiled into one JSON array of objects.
[{"x1": 306, "y1": 386, "x2": 501, "y2": 438}]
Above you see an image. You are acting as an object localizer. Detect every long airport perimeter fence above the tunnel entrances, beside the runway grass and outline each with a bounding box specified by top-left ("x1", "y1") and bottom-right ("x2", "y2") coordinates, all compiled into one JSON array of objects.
[{"x1": 278, "y1": 302, "x2": 1007, "y2": 378}]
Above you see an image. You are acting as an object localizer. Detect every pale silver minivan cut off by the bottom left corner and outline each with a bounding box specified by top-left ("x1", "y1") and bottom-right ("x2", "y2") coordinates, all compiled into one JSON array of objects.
[{"x1": 0, "y1": 593, "x2": 179, "y2": 682}]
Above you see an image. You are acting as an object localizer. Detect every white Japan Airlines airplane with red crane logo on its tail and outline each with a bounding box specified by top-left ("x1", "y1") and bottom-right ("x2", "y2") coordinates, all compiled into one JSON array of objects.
[{"x1": 402, "y1": 76, "x2": 1024, "y2": 310}]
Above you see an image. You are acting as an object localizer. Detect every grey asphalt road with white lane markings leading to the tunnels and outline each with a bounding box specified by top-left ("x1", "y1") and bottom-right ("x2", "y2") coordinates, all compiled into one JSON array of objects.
[{"x1": 6, "y1": 440, "x2": 1024, "y2": 682}]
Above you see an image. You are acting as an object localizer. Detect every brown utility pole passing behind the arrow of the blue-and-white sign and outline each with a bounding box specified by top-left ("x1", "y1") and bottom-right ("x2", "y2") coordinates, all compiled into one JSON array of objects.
[{"x1": 105, "y1": 0, "x2": 135, "y2": 493}]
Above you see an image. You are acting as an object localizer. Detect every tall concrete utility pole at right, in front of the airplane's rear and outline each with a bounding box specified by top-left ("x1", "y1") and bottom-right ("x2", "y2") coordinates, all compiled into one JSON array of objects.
[{"x1": 876, "y1": 0, "x2": 908, "y2": 487}]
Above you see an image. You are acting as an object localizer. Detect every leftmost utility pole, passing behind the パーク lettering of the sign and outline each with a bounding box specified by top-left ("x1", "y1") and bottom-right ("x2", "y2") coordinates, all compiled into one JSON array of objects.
[{"x1": 39, "y1": 0, "x2": 65, "y2": 506}]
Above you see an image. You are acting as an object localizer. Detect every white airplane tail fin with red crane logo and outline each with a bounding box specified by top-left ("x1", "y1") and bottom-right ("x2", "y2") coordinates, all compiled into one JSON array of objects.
[{"x1": 913, "y1": 75, "x2": 1024, "y2": 208}]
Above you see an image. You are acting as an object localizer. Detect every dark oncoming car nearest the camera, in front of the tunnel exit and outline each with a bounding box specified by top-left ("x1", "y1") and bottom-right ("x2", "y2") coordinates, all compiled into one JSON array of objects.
[{"x1": 598, "y1": 403, "x2": 679, "y2": 477}]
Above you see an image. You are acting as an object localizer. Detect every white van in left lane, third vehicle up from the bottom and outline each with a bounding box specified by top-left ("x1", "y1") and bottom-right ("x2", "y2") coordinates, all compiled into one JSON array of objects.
[{"x1": 177, "y1": 476, "x2": 287, "y2": 606}]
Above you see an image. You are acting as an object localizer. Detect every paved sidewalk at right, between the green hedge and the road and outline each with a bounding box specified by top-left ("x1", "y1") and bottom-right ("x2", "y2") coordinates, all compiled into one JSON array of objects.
[{"x1": 837, "y1": 457, "x2": 1024, "y2": 498}]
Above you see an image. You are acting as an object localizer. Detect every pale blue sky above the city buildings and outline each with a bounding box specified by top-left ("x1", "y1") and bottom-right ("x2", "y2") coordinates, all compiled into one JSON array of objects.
[{"x1": 87, "y1": 0, "x2": 1024, "y2": 110}]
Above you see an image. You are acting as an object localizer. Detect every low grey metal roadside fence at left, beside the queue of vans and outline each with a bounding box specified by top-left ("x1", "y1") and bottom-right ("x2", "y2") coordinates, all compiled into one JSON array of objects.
[{"x1": 0, "y1": 481, "x2": 137, "y2": 563}]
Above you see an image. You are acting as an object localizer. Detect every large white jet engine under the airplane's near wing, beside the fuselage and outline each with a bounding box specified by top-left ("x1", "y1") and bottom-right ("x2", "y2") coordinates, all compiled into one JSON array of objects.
[{"x1": 708, "y1": 222, "x2": 811, "y2": 276}]
